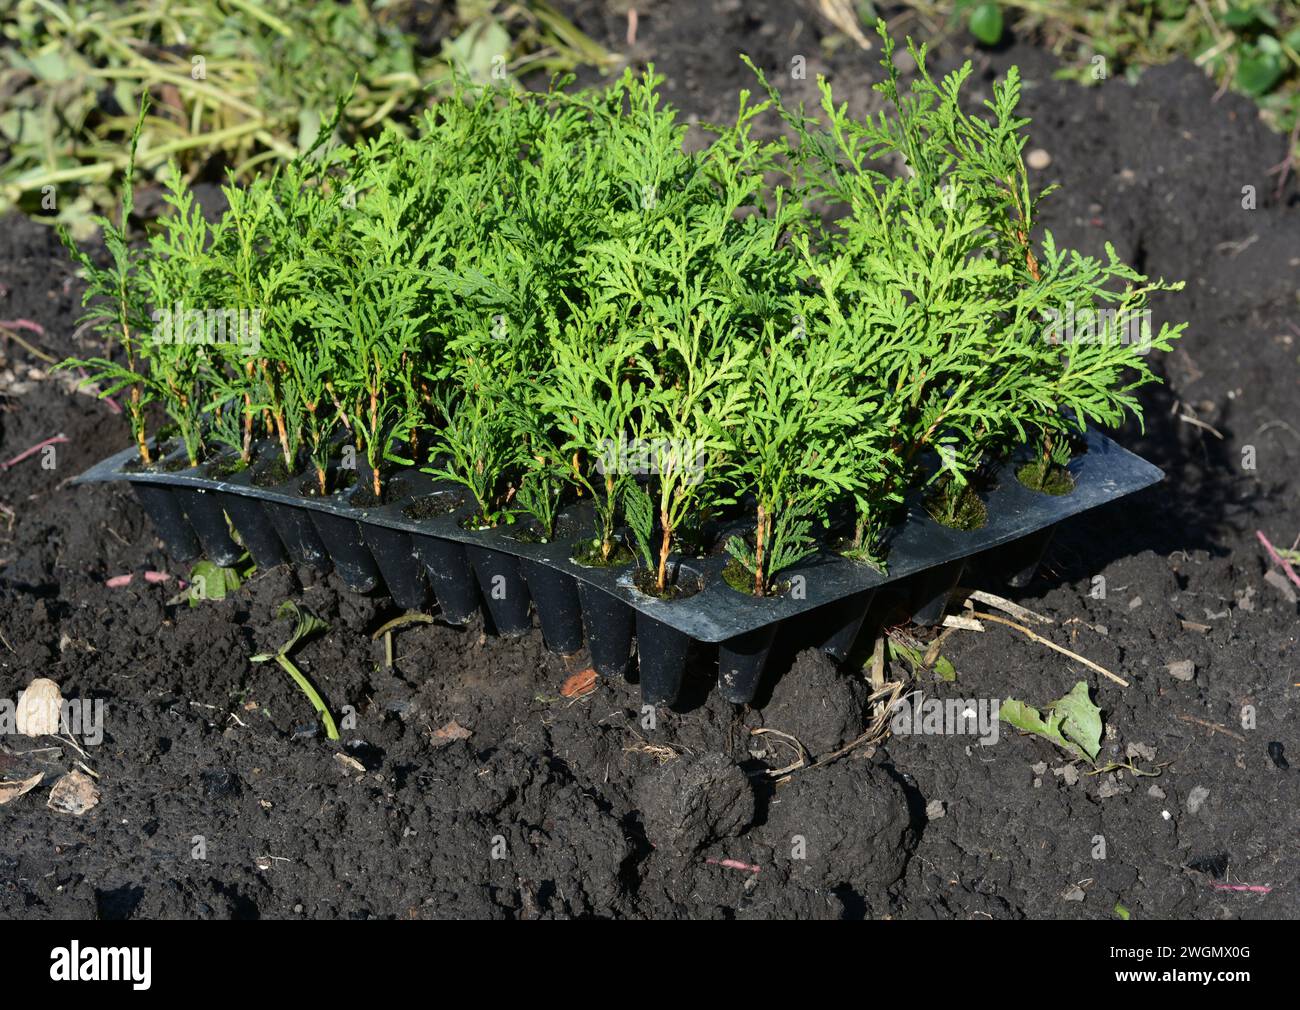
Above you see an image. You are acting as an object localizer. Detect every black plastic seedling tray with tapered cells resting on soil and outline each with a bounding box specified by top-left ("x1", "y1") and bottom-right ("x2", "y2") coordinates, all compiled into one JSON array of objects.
[{"x1": 74, "y1": 432, "x2": 1162, "y2": 705}]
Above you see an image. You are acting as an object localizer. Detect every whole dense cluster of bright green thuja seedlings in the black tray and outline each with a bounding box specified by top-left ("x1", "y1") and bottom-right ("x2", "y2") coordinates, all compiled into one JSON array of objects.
[{"x1": 69, "y1": 41, "x2": 1183, "y2": 613}]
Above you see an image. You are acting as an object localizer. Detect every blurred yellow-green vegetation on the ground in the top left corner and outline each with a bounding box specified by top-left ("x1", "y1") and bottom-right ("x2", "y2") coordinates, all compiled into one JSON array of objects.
[{"x1": 0, "y1": 0, "x2": 615, "y2": 235}]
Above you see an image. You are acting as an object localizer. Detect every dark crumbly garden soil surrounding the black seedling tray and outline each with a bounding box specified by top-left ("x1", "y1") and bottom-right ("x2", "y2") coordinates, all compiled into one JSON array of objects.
[{"x1": 0, "y1": 0, "x2": 1300, "y2": 919}]
